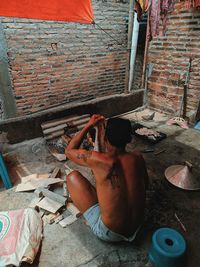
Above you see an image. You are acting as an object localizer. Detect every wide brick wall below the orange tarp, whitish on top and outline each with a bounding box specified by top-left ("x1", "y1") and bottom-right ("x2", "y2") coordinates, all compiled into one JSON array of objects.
[{"x1": 1, "y1": 0, "x2": 129, "y2": 116}]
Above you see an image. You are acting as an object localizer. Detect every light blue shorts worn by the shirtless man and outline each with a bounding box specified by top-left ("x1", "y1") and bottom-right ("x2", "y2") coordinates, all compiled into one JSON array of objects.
[{"x1": 83, "y1": 203, "x2": 140, "y2": 242}]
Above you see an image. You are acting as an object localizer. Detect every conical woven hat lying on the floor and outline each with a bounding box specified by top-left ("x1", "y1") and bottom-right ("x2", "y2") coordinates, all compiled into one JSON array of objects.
[{"x1": 165, "y1": 164, "x2": 200, "y2": 190}]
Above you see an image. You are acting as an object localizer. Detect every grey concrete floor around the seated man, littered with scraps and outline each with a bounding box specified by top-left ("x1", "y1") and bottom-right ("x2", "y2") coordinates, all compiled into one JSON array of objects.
[{"x1": 0, "y1": 110, "x2": 200, "y2": 267}]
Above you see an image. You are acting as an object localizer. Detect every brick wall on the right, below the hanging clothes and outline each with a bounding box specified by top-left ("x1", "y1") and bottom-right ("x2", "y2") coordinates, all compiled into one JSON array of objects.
[{"x1": 148, "y1": 1, "x2": 200, "y2": 114}]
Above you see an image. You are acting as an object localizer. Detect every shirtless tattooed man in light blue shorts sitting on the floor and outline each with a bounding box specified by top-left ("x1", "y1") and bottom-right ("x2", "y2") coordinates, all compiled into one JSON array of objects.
[{"x1": 65, "y1": 115, "x2": 148, "y2": 242}]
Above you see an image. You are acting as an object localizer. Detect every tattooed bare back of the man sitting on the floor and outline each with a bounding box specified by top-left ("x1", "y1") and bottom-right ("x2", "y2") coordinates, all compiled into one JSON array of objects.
[{"x1": 92, "y1": 153, "x2": 147, "y2": 236}]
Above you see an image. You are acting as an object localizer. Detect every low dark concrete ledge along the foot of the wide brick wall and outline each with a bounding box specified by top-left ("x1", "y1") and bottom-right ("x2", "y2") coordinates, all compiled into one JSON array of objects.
[{"x1": 0, "y1": 90, "x2": 143, "y2": 143}]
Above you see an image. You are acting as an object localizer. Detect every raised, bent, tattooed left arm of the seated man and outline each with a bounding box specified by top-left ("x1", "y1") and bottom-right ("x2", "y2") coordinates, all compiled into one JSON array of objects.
[{"x1": 65, "y1": 115, "x2": 104, "y2": 167}]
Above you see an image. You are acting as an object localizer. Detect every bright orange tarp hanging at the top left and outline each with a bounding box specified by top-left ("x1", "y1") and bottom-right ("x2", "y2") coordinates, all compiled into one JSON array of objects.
[{"x1": 0, "y1": 0, "x2": 94, "y2": 23}]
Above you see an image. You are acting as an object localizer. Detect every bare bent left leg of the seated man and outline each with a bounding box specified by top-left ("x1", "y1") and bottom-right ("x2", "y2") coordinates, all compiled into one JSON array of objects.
[{"x1": 66, "y1": 171, "x2": 98, "y2": 213}]
